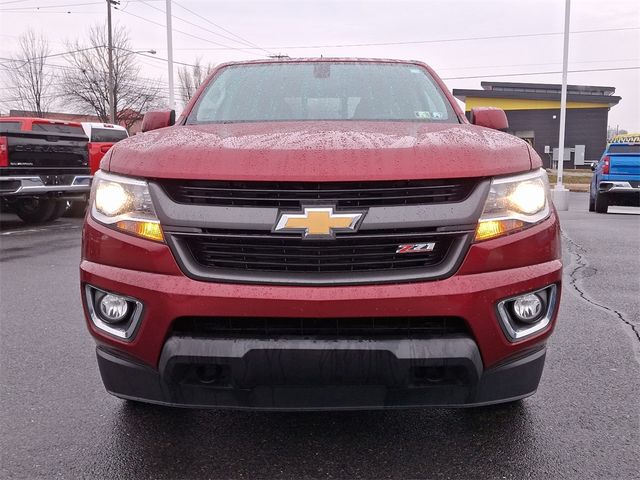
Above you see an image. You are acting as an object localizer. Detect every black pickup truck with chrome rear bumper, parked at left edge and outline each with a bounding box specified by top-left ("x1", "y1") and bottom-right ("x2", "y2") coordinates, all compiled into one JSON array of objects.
[{"x1": 0, "y1": 117, "x2": 91, "y2": 223}]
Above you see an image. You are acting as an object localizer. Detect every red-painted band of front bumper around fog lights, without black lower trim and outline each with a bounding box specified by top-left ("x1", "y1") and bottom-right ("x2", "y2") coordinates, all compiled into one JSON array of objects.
[{"x1": 81, "y1": 260, "x2": 562, "y2": 367}]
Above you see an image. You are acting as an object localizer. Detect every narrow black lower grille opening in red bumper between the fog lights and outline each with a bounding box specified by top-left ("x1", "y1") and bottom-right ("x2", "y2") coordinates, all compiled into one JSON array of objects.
[{"x1": 172, "y1": 317, "x2": 470, "y2": 339}]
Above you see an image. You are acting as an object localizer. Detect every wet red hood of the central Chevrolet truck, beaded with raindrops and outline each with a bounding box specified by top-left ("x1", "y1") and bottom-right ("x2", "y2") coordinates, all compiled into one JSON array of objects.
[{"x1": 107, "y1": 121, "x2": 532, "y2": 181}]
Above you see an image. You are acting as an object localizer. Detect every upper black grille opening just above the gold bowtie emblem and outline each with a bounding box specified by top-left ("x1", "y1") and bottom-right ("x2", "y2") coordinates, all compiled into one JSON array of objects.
[{"x1": 159, "y1": 179, "x2": 477, "y2": 209}]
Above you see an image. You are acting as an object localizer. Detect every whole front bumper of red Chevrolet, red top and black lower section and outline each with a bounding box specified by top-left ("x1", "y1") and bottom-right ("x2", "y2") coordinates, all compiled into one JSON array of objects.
[{"x1": 82, "y1": 260, "x2": 561, "y2": 409}]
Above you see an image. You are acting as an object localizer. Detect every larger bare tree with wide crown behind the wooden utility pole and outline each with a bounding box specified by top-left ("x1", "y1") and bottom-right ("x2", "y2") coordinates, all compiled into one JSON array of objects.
[{"x1": 61, "y1": 25, "x2": 163, "y2": 128}]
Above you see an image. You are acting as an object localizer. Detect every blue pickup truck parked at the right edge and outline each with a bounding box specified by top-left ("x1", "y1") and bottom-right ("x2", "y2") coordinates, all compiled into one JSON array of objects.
[{"x1": 589, "y1": 135, "x2": 640, "y2": 213}]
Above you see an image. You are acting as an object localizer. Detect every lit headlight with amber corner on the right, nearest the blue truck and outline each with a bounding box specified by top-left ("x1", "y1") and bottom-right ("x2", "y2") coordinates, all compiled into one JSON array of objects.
[{"x1": 476, "y1": 169, "x2": 550, "y2": 241}]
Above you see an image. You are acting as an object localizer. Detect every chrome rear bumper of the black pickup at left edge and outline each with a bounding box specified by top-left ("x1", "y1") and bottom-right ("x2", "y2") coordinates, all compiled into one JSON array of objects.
[{"x1": 0, "y1": 175, "x2": 93, "y2": 196}]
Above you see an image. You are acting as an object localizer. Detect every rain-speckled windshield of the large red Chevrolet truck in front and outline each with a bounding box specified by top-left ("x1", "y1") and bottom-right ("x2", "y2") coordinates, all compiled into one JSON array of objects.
[{"x1": 187, "y1": 62, "x2": 459, "y2": 124}]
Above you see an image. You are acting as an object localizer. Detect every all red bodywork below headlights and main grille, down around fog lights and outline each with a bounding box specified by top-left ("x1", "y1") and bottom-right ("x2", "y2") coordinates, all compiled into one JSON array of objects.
[{"x1": 80, "y1": 210, "x2": 562, "y2": 367}]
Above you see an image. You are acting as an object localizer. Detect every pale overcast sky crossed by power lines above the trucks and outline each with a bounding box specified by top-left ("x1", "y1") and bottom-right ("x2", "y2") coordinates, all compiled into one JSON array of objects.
[{"x1": 0, "y1": 0, "x2": 640, "y2": 131}]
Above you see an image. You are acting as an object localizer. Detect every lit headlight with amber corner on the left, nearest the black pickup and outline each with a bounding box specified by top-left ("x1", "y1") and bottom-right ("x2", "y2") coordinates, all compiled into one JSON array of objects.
[{"x1": 91, "y1": 171, "x2": 164, "y2": 242}]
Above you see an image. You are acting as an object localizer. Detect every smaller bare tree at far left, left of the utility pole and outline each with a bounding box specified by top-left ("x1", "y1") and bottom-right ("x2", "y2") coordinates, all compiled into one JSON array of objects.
[{"x1": 5, "y1": 30, "x2": 53, "y2": 117}]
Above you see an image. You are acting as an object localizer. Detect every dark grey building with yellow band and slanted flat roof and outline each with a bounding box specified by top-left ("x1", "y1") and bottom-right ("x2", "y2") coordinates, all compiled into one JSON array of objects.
[{"x1": 453, "y1": 82, "x2": 620, "y2": 168}]
